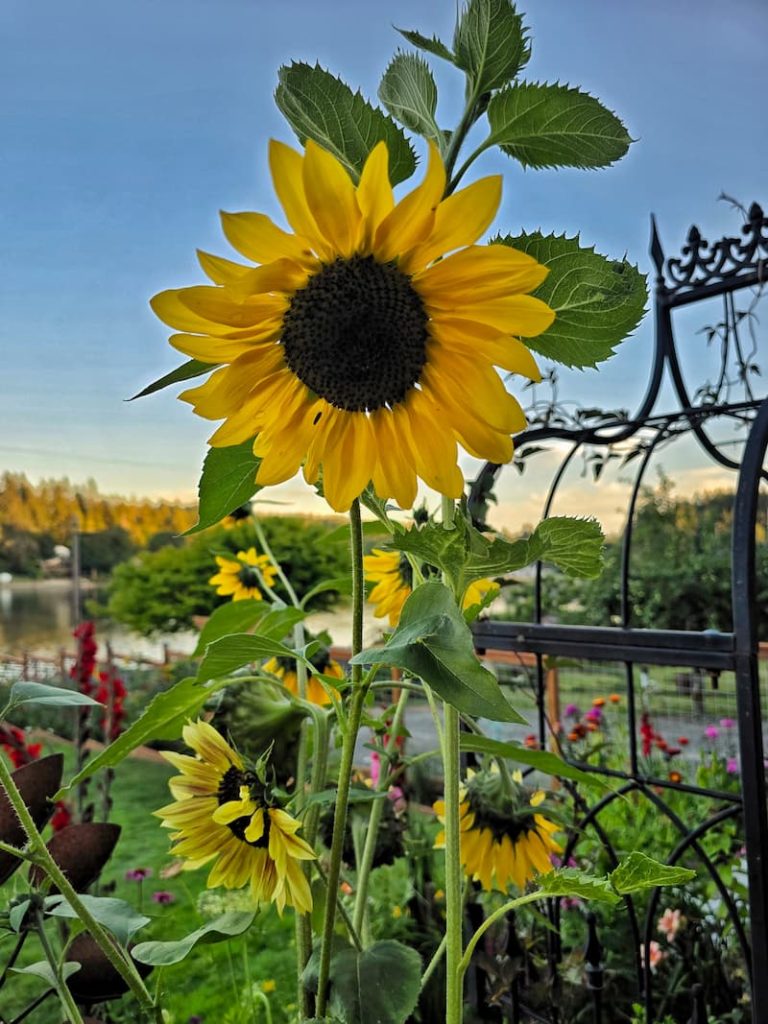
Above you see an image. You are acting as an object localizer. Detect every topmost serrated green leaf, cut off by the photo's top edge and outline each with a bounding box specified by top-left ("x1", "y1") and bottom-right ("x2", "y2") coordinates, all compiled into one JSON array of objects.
[{"x1": 454, "y1": 0, "x2": 530, "y2": 95}]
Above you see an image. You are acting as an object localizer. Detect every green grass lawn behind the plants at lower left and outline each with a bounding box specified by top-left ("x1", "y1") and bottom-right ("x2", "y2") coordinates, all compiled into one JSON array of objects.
[{"x1": 0, "y1": 745, "x2": 296, "y2": 1024}]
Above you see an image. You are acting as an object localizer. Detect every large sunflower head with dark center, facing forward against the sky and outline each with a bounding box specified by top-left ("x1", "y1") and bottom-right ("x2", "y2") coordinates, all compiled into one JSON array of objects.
[{"x1": 152, "y1": 141, "x2": 554, "y2": 511}]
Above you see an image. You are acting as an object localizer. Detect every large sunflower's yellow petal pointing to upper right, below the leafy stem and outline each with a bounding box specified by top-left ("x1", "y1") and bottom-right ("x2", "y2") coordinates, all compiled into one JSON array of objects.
[{"x1": 403, "y1": 174, "x2": 502, "y2": 273}]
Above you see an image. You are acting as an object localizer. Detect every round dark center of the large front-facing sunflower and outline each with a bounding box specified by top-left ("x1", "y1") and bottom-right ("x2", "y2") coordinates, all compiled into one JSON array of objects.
[{"x1": 283, "y1": 256, "x2": 427, "y2": 413}]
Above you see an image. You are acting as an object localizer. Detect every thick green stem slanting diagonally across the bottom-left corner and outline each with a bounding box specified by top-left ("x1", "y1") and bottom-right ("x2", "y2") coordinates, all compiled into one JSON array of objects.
[{"x1": 0, "y1": 758, "x2": 160, "y2": 1019}]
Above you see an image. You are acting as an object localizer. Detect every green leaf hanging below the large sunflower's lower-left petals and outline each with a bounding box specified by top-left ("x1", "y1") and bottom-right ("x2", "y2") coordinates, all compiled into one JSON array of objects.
[{"x1": 186, "y1": 438, "x2": 261, "y2": 534}]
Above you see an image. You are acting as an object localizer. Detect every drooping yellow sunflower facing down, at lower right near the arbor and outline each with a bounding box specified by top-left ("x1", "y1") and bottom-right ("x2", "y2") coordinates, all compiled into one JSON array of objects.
[{"x1": 433, "y1": 788, "x2": 562, "y2": 892}]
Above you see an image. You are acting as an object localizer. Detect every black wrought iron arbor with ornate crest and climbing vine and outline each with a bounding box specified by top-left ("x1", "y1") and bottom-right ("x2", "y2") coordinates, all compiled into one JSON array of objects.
[{"x1": 470, "y1": 204, "x2": 768, "y2": 1024}]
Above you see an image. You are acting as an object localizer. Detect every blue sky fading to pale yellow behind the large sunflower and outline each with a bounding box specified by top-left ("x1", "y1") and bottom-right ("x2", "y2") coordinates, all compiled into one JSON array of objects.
[{"x1": 0, "y1": 0, "x2": 768, "y2": 524}]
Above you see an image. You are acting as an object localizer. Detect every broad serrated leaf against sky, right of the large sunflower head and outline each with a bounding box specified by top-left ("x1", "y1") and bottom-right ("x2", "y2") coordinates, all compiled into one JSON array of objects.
[{"x1": 494, "y1": 231, "x2": 648, "y2": 367}]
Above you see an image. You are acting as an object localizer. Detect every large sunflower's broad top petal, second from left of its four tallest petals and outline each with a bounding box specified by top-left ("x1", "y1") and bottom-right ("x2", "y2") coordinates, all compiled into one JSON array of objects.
[{"x1": 302, "y1": 139, "x2": 360, "y2": 256}]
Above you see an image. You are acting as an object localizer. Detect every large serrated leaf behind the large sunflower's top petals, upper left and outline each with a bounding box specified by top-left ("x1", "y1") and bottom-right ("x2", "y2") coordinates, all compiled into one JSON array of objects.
[{"x1": 274, "y1": 63, "x2": 416, "y2": 184}]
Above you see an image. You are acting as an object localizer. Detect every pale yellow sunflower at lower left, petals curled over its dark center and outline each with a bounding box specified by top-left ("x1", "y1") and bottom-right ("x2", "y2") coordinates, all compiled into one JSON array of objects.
[{"x1": 155, "y1": 721, "x2": 314, "y2": 913}]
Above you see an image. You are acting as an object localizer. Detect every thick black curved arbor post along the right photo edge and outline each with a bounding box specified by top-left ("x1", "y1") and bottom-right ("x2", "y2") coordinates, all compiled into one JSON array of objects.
[{"x1": 731, "y1": 400, "x2": 768, "y2": 1009}]
